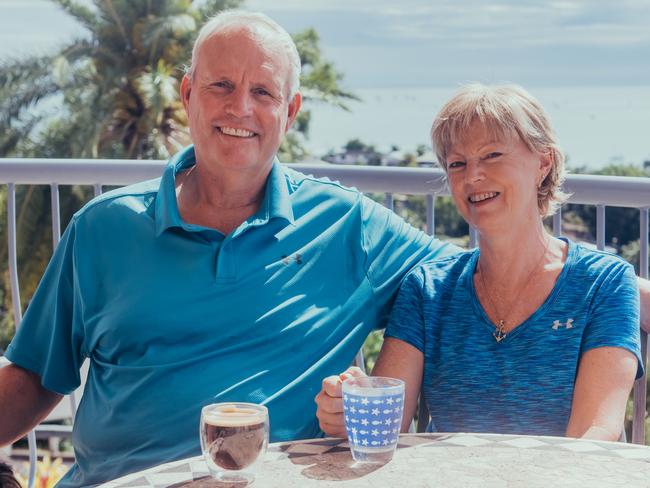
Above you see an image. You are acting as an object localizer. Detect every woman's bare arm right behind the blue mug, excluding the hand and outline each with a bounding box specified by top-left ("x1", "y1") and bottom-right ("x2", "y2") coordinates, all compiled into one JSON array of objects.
[{"x1": 372, "y1": 337, "x2": 424, "y2": 432}]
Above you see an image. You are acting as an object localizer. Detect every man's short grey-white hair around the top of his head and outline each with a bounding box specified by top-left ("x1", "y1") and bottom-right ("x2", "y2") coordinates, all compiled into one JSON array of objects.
[{"x1": 187, "y1": 10, "x2": 300, "y2": 99}]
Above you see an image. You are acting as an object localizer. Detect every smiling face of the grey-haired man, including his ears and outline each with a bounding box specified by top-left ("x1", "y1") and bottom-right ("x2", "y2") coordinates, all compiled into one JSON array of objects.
[{"x1": 181, "y1": 29, "x2": 301, "y2": 174}]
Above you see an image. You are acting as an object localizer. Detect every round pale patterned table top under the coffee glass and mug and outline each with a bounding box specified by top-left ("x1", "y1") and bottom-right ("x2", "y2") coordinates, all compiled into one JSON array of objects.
[{"x1": 101, "y1": 433, "x2": 650, "y2": 488}]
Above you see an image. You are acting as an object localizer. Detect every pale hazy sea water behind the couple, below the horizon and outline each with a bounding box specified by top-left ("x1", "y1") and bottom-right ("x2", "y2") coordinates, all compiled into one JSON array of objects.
[{"x1": 305, "y1": 86, "x2": 650, "y2": 169}]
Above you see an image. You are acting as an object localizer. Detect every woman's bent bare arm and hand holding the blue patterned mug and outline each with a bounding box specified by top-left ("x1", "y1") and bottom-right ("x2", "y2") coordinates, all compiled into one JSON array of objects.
[{"x1": 315, "y1": 337, "x2": 424, "y2": 437}]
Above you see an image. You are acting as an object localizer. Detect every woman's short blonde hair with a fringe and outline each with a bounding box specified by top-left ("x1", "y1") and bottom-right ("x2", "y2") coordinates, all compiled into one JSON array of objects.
[{"x1": 431, "y1": 83, "x2": 569, "y2": 217}]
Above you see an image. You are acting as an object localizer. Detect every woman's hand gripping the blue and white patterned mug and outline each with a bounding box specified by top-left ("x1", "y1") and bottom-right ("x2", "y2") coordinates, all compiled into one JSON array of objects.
[{"x1": 314, "y1": 366, "x2": 366, "y2": 437}]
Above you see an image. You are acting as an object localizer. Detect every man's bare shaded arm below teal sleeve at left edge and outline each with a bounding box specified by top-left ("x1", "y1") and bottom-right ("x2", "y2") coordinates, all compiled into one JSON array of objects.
[{"x1": 0, "y1": 364, "x2": 63, "y2": 446}]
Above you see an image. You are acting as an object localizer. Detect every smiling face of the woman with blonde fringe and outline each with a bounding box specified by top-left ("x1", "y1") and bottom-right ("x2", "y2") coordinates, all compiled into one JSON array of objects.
[{"x1": 446, "y1": 122, "x2": 552, "y2": 233}]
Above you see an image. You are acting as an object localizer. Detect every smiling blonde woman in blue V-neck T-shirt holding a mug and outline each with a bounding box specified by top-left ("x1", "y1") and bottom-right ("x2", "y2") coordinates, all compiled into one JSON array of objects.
[{"x1": 316, "y1": 85, "x2": 643, "y2": 440}]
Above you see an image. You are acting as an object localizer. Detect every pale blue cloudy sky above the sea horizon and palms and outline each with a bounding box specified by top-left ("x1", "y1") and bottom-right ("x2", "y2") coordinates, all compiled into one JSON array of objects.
[{"x1": 0, "y1": 0, "x2": 650, "y2": 89}]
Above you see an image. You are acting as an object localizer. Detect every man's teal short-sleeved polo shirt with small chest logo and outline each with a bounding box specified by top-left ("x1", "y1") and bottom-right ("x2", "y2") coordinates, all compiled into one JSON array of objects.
[{"x1": 7, "y1": 147, "x2": 456, "y2": 486}]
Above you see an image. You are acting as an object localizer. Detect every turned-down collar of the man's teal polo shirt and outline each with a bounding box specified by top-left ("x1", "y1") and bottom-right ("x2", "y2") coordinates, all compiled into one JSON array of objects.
[{"x1": 155, "y1": 146, "x2": 295, "y2": 237}]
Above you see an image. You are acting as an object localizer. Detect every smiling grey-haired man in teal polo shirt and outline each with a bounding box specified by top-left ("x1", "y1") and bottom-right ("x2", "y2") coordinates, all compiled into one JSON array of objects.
[{"x1": 0, "y1": 12, "x2": 455, "y2": 487}]
